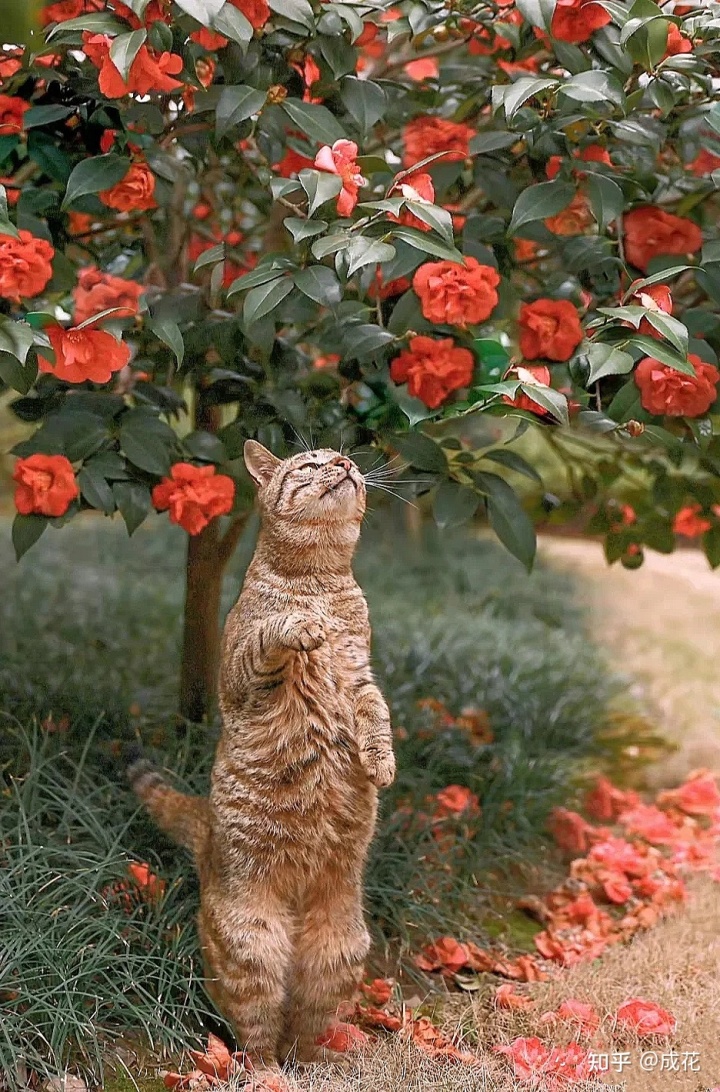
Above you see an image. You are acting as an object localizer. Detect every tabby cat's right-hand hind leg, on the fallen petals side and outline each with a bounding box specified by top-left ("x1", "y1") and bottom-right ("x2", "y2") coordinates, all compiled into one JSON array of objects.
[{"x1": 280, "y1": 862, "x2": 370, "y2": 1063}]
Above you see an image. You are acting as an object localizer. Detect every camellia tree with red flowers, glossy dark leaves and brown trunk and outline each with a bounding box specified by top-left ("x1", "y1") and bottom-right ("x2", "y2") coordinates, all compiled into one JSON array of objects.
[{"x1": 0, "y1": 0, "x2": 720, "y2": 719}]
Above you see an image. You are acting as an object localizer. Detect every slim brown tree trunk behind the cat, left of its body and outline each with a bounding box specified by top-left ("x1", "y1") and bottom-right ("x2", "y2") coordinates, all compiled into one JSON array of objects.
[{"x1": 180, "y1": 520, "x2": 225, "y2": 722}]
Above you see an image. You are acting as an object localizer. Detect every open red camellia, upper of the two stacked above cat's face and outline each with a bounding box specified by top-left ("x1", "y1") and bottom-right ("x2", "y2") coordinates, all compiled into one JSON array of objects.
[{"x1": 413, "y1": 258, "x2": 500, "y2": 327}]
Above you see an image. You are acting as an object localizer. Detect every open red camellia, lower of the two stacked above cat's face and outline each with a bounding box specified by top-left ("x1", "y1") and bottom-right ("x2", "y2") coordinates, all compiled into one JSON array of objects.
[{"x1": 390, "y1": 335, "x2": 475, "y2": 410}]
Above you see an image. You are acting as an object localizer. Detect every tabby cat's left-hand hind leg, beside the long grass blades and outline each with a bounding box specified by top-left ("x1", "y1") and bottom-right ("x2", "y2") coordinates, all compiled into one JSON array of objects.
[{"x1": 199, "y1": 891, "x2": 292, "y2": 1070}]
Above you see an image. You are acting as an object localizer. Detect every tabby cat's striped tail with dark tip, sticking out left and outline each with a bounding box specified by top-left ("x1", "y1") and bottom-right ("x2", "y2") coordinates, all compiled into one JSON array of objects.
[{"x1": 126, "y1": 752, "x2": 210, "y2": 860}]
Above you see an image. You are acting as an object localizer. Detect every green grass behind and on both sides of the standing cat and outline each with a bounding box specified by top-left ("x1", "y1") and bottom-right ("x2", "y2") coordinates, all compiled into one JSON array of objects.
[{"x1": 0, "y1": 508, "x2": 617, "y2": 1087}]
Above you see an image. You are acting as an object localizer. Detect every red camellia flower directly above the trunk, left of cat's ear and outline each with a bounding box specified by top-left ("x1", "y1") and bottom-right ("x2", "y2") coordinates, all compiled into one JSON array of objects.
[{"x1": 153, "y1": 463, "x2": 235, "y2": 535}]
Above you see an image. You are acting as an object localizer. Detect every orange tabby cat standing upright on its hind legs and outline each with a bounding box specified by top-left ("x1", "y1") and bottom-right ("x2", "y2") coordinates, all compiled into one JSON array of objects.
[{"x1": 131, "y1": 440, "x2": 394, "y2": 1068}]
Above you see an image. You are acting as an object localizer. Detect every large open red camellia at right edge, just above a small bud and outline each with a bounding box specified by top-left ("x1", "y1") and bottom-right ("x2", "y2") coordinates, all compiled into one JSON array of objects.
[{"x1": 635, "y1": 353, "x2": 720, "y2": 417}]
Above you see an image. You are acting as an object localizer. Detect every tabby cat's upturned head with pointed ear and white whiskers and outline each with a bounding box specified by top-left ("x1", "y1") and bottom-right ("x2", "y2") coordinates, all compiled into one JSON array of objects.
[{"x1": 244, "y1": 440, "x2": 365, "y2": 524}]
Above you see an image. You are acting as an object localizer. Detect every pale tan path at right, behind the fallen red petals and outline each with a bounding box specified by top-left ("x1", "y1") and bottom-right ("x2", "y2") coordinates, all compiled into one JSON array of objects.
[{"x1": 541, "y1": 538, "x2": 720, "y2": 786}]
